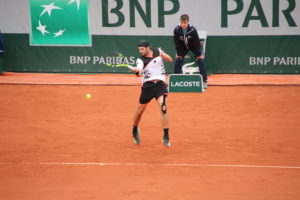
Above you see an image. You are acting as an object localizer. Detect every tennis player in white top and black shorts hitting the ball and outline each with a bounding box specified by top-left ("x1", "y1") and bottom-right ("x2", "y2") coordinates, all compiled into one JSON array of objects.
[{"x1": 128, "y1": 40, "x2": 173, "y2": 147}]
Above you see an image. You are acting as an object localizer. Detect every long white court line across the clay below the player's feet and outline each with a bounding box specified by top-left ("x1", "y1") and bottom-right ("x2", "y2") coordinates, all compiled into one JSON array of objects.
[{"x1": 40, "y1": 162, "x2": 300, "y2": 169}]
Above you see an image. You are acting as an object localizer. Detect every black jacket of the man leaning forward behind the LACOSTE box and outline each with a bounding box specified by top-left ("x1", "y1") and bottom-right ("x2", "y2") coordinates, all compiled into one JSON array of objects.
[{"x1": 174, "y1": 24, "x2": 201, "y2": 56}]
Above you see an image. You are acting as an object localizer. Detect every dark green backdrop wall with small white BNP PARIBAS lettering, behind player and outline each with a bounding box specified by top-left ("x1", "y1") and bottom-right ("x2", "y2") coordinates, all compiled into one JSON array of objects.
[{"x1": 3, "y1": 34, "x2": 300, "y2": 74}]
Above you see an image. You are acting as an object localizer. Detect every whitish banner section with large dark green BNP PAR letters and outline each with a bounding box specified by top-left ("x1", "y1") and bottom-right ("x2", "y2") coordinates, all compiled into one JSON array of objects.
[{"x1": 94, "y1": 0, "x2": 300, "y2": 35}]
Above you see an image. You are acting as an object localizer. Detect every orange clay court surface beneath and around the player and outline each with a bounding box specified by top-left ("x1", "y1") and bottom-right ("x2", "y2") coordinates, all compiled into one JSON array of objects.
[{"x1": 0, "y1": 73, "x2": 300, "y2": 200}]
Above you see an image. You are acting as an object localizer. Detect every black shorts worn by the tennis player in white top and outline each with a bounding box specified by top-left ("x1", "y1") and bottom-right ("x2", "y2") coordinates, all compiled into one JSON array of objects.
[{"x1": 139, "y1": 81, "x2": 168, "y2": 104}]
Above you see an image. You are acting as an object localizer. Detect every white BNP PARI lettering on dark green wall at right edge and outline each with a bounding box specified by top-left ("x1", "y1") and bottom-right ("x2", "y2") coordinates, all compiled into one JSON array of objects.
[{"x1": 249, "y1": 57, "x2": 300, "y2": 66}]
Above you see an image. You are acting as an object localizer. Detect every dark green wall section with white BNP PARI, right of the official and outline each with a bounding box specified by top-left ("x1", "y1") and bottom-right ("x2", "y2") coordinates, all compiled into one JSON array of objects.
[{"x1": 206, "y1": 36, "x2": 300, "y2": 74}]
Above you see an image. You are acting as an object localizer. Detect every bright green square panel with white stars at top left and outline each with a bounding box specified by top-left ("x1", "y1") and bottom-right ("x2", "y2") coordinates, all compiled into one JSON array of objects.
[{"x1": 29, "y1": 0, "x2": 91, "y2": 46}]
